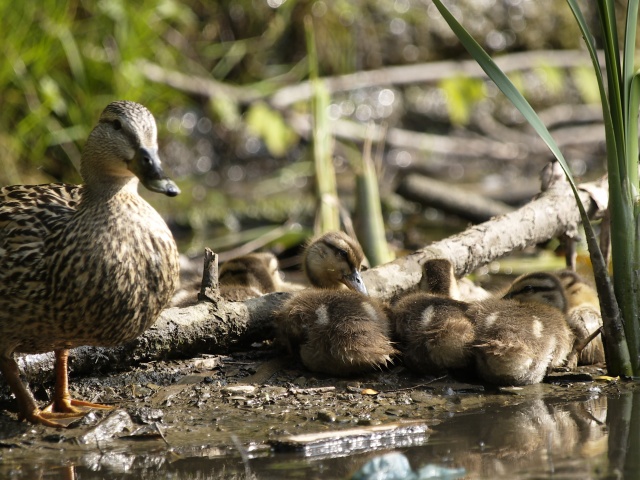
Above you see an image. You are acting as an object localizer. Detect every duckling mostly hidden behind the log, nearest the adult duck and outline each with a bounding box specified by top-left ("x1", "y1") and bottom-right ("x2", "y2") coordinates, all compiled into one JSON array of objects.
[{"x1": 218, "y1": 252, "x2": 280, "y2": 302}]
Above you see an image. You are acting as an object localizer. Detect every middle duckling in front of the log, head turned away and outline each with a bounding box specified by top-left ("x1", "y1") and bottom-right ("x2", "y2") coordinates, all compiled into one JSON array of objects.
[{"x1": 391, "y1": 259, "x2": 475, "y2": 375}]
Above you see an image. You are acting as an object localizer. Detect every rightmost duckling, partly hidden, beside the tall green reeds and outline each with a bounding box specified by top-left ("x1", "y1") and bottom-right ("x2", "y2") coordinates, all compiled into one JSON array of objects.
[{"x1": 556, "y1": 270, "x2": 605, "y2": 365}]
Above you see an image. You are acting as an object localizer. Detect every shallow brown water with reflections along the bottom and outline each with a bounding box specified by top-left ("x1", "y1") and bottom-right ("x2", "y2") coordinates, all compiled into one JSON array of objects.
[{"x1": 5, "y1": 391, "x2": 640, "y2": 479}]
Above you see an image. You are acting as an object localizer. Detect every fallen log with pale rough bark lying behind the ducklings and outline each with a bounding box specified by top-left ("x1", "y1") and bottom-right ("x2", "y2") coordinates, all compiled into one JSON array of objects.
[{"x1": 13, "y1": 168, "x2": 607, "y2": 381}]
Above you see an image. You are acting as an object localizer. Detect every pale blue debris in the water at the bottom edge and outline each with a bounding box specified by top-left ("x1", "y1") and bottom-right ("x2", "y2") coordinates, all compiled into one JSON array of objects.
[{"x1": 351, "y1": 452, "x2": 466, "y2": 480}]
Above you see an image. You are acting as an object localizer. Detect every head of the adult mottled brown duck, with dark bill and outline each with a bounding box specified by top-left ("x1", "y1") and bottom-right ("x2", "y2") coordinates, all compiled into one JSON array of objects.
[{"x1": 80, "y1": 100, "x2": 180, "y2": 197}]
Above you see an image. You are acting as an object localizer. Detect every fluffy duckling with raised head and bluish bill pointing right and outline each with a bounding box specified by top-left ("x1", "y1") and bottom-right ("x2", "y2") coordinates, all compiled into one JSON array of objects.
[{"x1": 275, "y1": 232, "x2": 396, "y2": 376}]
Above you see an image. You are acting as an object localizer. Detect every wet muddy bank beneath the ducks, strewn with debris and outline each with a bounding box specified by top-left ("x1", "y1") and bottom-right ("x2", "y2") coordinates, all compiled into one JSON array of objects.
[{"x1": 0, "y1": 344, "x2": 634, "y2": 478}]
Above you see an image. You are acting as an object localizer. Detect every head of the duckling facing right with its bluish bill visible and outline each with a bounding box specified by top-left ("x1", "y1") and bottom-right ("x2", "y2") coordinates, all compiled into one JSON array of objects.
[{"x1": 302, "y1": 232, "x2": 367, "y2": 295}]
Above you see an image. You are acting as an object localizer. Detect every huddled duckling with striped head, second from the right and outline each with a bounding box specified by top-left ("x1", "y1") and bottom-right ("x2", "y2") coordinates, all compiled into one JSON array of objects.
[{"x1": 467, "y1": 272, "x2": 573, "y2": 385}]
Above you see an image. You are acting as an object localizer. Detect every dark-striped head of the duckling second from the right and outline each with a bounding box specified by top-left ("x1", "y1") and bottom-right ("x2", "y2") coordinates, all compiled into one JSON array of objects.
[{"x1": 503, "y1": 272, "x2": 568, "y2": 313}]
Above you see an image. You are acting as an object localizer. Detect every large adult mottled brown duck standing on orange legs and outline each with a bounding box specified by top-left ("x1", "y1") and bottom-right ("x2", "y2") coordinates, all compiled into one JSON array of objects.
[{"x1": 0, "y1": 101, "x2": 180, "y2": 427}]
